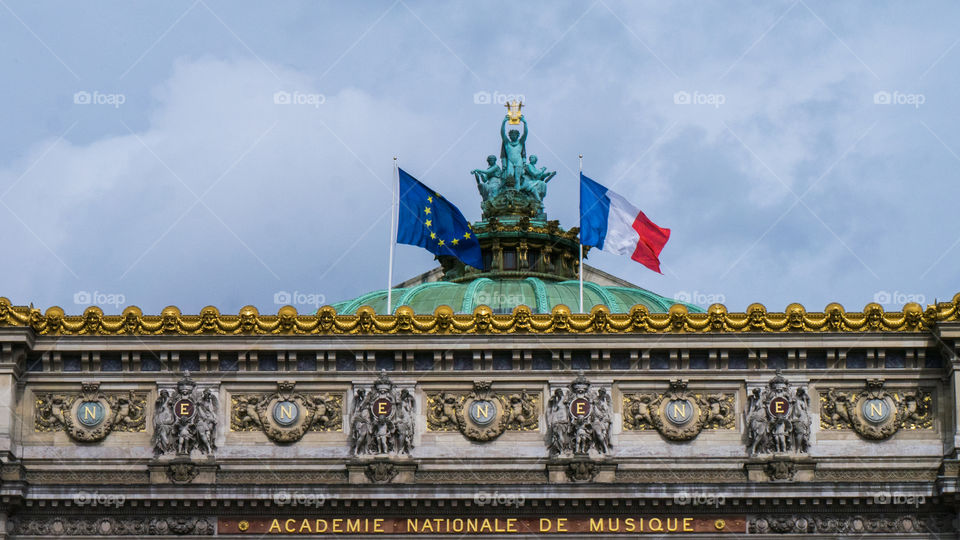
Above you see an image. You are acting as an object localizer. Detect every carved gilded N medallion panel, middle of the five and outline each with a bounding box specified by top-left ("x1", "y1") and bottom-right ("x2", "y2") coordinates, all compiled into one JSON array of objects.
[{"x1": 427, "y1": 381, "x2": 540, "y2": 441}]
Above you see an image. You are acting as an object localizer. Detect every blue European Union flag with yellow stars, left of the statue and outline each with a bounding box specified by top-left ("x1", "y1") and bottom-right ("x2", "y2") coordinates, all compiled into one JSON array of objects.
[{"x1": 397, "y1": 169, "x2": 483, "y2": 269}]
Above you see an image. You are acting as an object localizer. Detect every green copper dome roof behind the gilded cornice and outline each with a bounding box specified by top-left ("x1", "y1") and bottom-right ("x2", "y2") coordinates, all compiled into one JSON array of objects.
[{"x1": 333, "y1": 277, "x2": 702, "y2": 315}]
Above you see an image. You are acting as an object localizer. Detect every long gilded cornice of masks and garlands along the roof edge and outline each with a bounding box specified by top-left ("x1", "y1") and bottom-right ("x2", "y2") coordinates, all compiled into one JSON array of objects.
[{"x1": 0, "y1": 293, "x2": 960, "y2": 335}]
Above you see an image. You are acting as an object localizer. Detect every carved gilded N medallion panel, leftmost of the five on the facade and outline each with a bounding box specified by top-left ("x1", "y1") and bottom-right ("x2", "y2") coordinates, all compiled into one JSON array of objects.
[{"x1": 34, "y1": 383, "x2": 147, "y2": 442}]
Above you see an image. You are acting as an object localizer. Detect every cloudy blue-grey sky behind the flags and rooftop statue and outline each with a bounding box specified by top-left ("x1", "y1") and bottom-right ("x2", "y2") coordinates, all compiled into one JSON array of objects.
[{"x1": 0, "y1": 0, "x2": 960, "y2": 313}]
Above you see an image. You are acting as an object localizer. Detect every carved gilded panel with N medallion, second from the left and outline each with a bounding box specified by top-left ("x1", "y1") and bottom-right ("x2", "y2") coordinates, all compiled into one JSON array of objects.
[{"x1": 230, "y1": 381, "x2": 343, "y2": 443}]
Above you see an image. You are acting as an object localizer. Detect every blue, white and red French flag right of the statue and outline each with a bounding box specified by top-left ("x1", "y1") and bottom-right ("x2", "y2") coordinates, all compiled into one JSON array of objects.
[{"x1": 580, "y1": 173, "x2": 670, "y2": 274}]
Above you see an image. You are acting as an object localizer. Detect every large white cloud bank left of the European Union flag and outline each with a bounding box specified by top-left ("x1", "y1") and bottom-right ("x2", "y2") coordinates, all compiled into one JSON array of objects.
[{"x1": 0, "y1": 59, "x2": 440, "y2": 311}]
